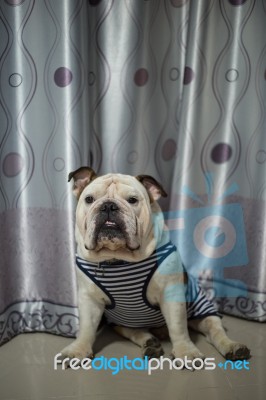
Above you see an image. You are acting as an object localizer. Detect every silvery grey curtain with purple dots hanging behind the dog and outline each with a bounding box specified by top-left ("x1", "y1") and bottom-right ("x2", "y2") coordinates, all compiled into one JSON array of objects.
[{"x1": 0, "y1": 0, "x2": 266, "y2": 343}]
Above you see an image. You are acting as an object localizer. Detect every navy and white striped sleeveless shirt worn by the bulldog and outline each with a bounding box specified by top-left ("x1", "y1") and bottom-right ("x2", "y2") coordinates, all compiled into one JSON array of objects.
[{"x1": 76, "y1": 242, "x2": 217, "y2": 328}]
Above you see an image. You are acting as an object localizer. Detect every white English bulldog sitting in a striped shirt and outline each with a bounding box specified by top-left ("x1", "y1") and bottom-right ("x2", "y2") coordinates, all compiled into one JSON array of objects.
[{"x1": 61, "y1": 167, "x2": 250, "y2": 360}]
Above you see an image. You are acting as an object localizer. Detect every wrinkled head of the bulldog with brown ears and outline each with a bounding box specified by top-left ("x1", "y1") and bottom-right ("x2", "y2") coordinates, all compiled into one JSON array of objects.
[{"x1": 69, "y1": 167, "x2": 167, "y2": 261}]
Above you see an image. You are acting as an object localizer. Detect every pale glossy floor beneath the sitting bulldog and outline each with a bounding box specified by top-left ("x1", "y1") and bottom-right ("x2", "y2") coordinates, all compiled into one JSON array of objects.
[{"x1": 0, "y1": 316, "x2": 266, "y2": 400}]
